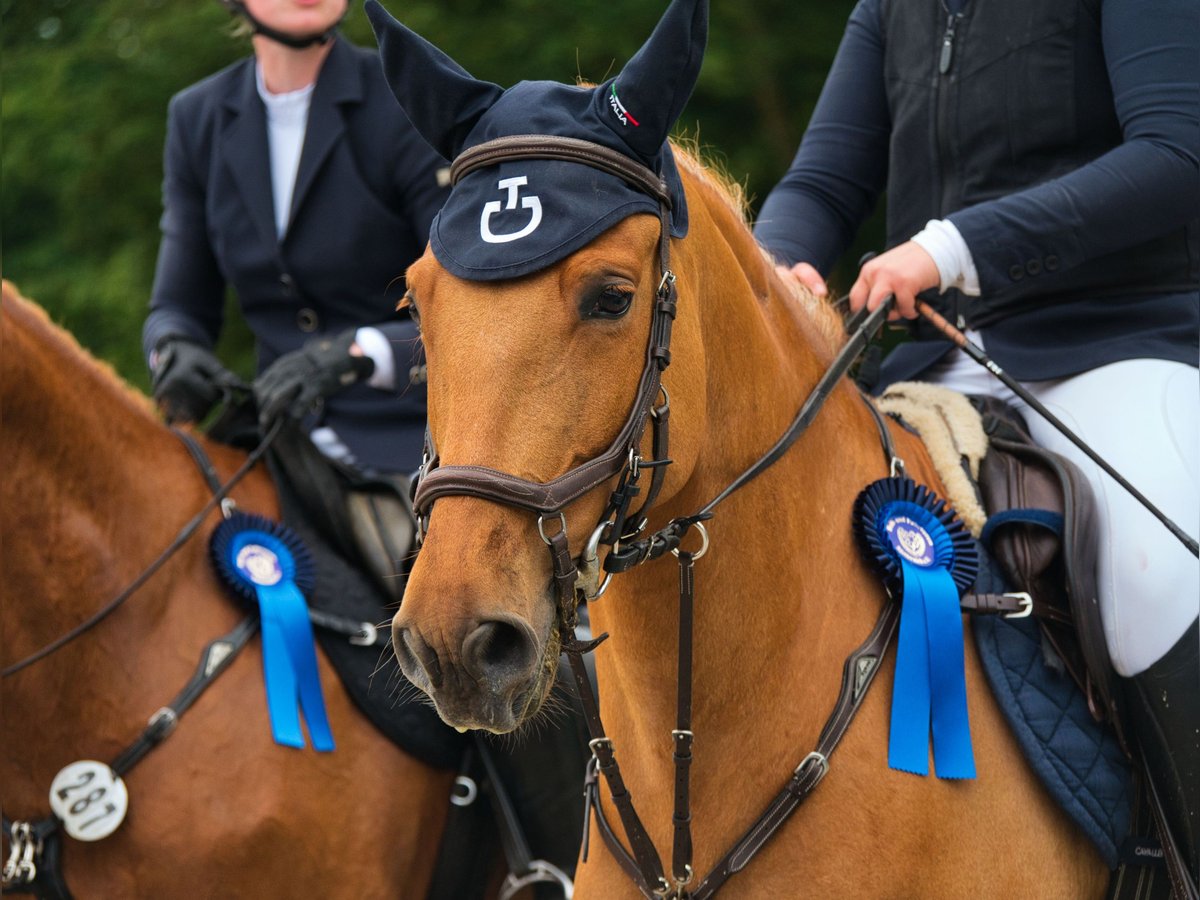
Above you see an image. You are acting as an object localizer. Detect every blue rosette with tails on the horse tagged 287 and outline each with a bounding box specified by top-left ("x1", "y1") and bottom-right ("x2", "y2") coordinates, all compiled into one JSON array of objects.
[{"x1": 209, "y1": 512, "x2": 334, "y2": 751}]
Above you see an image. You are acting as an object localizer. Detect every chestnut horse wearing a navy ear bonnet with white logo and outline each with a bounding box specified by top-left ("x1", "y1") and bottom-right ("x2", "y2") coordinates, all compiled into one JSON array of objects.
[{"x1": 368, "y1": 0, "x2": 1108, "y2": 900}]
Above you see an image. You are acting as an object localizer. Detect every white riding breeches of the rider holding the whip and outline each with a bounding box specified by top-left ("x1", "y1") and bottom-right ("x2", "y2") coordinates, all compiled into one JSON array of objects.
[{"x1": 925, "y1": 332, "x2": 1200, "y2": 677}]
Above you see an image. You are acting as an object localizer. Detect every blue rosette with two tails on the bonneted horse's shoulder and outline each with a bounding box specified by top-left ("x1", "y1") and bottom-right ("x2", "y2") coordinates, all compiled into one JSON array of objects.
[{"x1": 854, "y1": 478, "x2": 979, "y2": 779}]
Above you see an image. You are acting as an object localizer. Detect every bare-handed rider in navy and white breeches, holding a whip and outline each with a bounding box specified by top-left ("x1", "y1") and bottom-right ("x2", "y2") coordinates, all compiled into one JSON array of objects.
[{"x1": 755, "y1": 0, "x2": 1200, "y2": 878}]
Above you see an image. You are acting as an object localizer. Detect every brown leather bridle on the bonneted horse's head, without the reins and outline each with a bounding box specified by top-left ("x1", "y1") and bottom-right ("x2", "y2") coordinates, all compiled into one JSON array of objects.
[{"x1": 413, "y1": 134, "x2": 676, "y2": 629}]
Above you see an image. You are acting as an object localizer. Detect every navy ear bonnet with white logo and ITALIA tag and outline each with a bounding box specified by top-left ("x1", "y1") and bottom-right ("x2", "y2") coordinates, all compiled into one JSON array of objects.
[{"x1": 366, "y1": 0, "x2": 708, "y2": 281}]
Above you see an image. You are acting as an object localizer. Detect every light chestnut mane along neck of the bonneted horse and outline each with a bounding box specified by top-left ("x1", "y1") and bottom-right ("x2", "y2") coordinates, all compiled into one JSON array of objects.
[{"x1": 671, "y1": 140, "x2": 844, "y2": 352}]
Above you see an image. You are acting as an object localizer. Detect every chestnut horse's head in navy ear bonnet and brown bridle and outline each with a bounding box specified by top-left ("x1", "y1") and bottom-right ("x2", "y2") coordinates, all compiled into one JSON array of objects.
[{"x1": 368, "y1": 0, "x2": 734, "y2": 732}]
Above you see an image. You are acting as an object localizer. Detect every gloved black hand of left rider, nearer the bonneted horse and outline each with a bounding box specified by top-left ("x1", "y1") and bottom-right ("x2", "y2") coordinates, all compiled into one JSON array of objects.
[{"x1": 254, "y1": 329, "x2": 374, "y2": 428}]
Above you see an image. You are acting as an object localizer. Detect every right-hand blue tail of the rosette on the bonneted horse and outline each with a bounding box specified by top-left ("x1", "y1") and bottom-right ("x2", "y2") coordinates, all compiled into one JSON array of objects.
[{"x1": 906, "y1": 569, "x2": 976, "y2": 778}]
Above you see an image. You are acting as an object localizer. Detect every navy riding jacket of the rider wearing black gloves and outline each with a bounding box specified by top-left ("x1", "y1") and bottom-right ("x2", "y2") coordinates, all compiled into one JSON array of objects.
[{"x1": 143, "y1": 37, "x2": 448, "y2": 472}]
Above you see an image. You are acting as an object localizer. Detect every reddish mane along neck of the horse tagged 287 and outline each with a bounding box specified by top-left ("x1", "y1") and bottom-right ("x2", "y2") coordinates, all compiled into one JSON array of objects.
[{"x1": 2, "y1": 280, "x2": 157, "y2": 421}]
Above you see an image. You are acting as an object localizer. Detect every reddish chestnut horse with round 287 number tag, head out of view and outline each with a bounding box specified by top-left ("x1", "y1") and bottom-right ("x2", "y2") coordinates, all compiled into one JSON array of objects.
[{"x1": 0, "y1": 283, "x2": 454, "y2": 898}]
